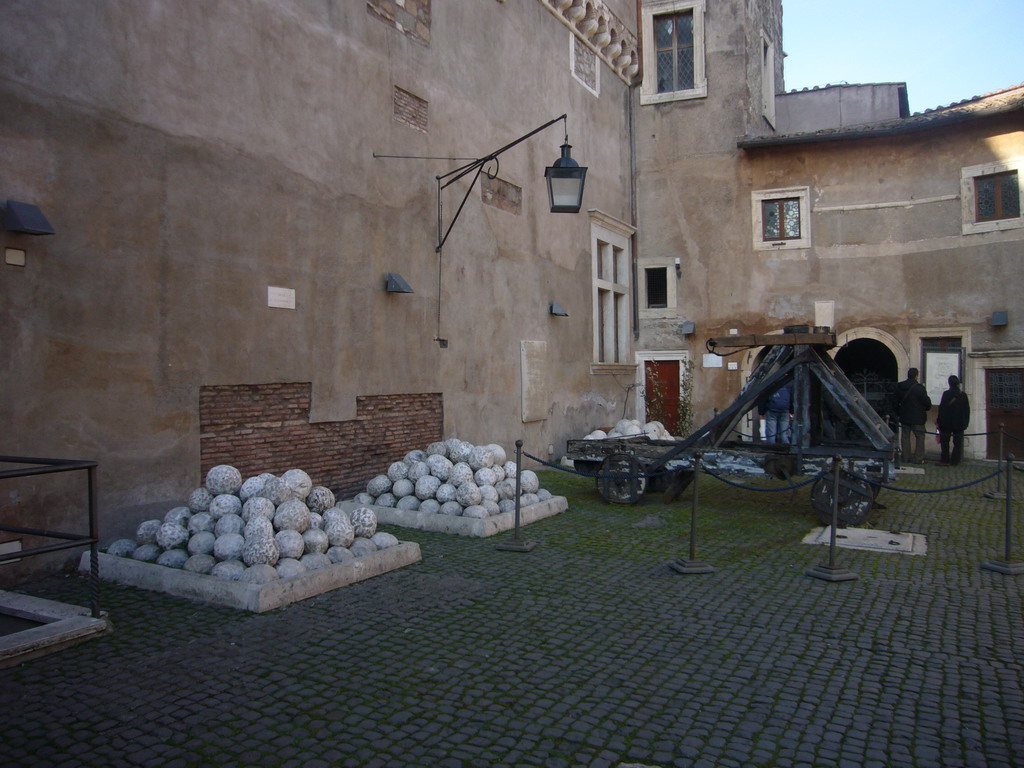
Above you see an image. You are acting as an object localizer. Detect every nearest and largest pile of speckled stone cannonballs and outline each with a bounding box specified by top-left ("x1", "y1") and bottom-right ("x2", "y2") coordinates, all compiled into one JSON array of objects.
[{"x1": 106, "y1": 465, "x2": 398, "y2": 584}]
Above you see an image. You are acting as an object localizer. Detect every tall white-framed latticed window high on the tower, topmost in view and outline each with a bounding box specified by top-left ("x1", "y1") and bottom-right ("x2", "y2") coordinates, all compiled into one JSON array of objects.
[{"x1": 640, "y1": 0, "x2": 708, "y2": 104}]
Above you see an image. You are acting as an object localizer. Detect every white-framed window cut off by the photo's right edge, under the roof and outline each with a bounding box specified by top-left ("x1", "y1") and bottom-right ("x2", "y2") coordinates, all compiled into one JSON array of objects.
[{"x1": 961, "y1": 158, "x2": 1024, "y2": 234}]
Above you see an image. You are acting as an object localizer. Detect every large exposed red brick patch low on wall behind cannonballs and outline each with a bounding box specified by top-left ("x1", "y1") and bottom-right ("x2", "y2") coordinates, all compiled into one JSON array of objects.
[{"x1": 199, "y1": 382, "x2": 443, "y2": 498}]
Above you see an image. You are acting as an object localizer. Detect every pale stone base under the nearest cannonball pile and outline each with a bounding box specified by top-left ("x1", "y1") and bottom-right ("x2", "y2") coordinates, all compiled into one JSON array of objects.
[{"x1": 79, "y1": 542, "x2": 423, "y2": 613}]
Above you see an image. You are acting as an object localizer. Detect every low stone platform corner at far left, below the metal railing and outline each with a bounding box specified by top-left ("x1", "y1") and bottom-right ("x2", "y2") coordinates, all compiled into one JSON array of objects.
[{"x1": 0, "y1": 590, "x2": 113, "y2": 668}]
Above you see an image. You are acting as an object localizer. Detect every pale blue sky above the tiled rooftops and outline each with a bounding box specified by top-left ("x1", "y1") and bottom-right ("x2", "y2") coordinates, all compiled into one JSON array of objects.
[{"x1": 782, "y1": 0, "x2": 1024, "y2": 113}]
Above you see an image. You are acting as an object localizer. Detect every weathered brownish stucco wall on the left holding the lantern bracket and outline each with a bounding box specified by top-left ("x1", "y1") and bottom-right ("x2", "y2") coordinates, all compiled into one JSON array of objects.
[{"x1": 0, "y1": 0, "x2": 630, "y2": 565}]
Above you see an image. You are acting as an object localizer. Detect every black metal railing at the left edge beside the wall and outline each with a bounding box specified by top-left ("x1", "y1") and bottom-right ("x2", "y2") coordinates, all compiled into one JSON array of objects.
[{"x1": 0, "y1": 456, "x2": 100, "y2": 618}]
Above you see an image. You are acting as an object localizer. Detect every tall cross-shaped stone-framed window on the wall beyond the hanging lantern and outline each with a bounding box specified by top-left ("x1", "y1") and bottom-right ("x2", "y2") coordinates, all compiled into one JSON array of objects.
[{"x1": 591, "y1": 214, "x2": 633, "y2": 366}]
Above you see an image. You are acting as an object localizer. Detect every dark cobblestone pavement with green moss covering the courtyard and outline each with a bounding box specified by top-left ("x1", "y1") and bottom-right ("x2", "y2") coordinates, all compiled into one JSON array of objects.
[{"x1": 0, "y1": 465, "x2": 1024, "y2": 768}]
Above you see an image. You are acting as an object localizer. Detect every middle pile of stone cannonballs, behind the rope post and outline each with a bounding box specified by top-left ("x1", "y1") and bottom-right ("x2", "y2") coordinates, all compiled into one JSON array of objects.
[{"x1": 354, "y1": 437, "x2": 551, "y2": 518}]
